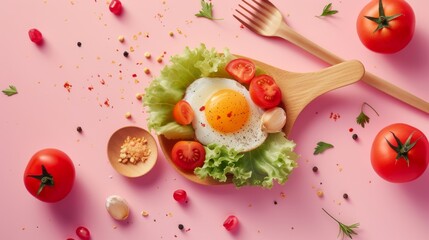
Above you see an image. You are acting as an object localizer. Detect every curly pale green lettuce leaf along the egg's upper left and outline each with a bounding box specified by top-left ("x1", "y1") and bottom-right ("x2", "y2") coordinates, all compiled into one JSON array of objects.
[{"x1": 143, "y1": 44, "x2": 233, "y2": 139}]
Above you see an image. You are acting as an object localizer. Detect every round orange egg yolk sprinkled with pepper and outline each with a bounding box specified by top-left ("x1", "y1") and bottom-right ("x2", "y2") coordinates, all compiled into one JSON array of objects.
[{"x1": 204, "y1": 89, "x2": 250, "y2": 133}]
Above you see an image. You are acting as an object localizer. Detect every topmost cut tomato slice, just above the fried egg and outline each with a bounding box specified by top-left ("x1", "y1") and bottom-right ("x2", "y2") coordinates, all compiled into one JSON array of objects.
[{"x1": 226, "y1": 58, "x2": 256, "y2": 83}]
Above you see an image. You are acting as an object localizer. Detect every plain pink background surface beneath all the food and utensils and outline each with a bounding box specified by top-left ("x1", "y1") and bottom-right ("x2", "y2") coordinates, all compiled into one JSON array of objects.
[{"x1": 0, "y1": 0, "x2": 429, "y2": 240}]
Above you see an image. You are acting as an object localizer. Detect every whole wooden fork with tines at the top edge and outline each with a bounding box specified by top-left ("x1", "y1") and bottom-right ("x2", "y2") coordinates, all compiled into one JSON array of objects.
[{"x1": 233, "y1": 0, "x2": 429, "y2": 113}]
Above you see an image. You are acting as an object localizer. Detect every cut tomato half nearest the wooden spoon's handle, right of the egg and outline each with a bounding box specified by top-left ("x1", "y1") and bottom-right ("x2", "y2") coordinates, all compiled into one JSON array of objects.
[{"x1": 249, "y1": 74, "x2": 282, "y2": 109}]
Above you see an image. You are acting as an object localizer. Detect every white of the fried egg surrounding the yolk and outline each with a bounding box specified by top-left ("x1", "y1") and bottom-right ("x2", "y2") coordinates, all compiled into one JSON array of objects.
[{"x1": 184, "y1": 78, "x2": 268, "y2": 152}]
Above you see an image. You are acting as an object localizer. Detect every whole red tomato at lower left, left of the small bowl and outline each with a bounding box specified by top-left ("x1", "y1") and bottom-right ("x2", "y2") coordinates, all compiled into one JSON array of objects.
[{"x1": 24, "y1": 148, "x2": 75, "y2": 202}]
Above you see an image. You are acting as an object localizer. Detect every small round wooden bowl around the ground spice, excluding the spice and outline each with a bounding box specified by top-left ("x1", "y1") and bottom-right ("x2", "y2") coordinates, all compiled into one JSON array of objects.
[{"x1": 107, "y1": 126, "x2": 158, "y2": 178}]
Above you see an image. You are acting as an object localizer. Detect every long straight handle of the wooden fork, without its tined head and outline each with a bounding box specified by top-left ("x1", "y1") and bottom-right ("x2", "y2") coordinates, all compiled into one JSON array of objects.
[{"x1": 277, "y1": 25, "x2": 429, "y2": 113}]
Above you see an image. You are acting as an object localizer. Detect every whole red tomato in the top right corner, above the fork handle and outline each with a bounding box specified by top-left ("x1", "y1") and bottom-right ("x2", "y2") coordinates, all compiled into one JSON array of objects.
[{"x1": 356, "y1": 0, "x2": 415, "y2": 53}]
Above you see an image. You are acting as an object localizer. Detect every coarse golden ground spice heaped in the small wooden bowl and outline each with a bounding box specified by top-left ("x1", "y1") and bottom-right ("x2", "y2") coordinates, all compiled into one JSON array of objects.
[{"x1": 118, "y1": 136, "x2": 151, "y2": 164}]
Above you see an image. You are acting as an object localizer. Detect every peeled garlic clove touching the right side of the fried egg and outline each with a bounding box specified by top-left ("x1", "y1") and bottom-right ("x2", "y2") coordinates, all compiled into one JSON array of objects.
[{"x1": 261, "y1": 107, "x2": 286, "y2": 133}]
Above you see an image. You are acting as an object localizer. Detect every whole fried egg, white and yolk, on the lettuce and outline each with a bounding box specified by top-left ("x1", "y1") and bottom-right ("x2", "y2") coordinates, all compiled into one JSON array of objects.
[{"x1": 184, "y1": 78, "x2": 267, "y2": 152}]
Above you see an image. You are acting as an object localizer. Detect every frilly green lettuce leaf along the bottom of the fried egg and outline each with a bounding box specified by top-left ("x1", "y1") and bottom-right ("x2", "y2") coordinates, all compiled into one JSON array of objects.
[{"x1": 194, "y1": 133, "x2": 298, "y2": 188}]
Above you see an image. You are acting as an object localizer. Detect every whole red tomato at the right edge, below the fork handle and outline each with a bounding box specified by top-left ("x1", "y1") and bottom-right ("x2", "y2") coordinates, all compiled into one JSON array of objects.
[{"x1": 371, "y1": 123, "x2": 429, "y2": 183}]
